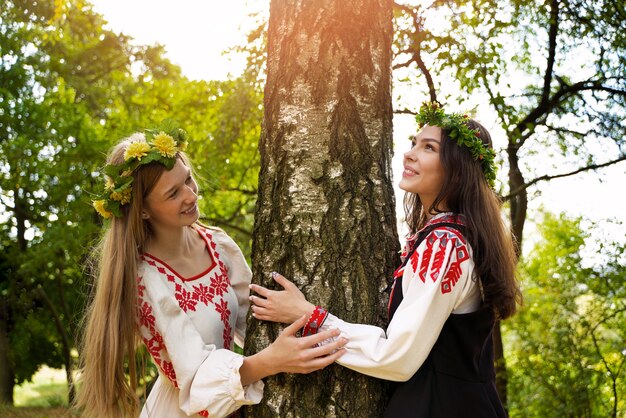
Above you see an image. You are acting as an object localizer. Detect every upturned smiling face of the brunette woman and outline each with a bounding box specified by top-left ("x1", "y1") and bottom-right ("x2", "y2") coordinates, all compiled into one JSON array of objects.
[{"x1": 400, "y1": 125, "x2": 445, "y2": 210}]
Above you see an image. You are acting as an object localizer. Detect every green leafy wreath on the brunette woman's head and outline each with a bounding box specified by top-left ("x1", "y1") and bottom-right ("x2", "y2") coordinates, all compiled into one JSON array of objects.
[{"x1": 415, "y1": 102, "x2": 496, "y2": 189}]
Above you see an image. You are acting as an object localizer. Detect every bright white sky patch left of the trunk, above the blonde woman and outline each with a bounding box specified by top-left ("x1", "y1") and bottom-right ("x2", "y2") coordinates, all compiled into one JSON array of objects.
[{"x1": 90, "y1": 0, "x2": 269, "y2": 80}]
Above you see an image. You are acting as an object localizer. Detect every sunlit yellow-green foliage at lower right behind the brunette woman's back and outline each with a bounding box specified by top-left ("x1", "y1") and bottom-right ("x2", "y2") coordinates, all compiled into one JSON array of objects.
[{"x1": 505, "y1": 214, "x2": 626, "y2": 417}]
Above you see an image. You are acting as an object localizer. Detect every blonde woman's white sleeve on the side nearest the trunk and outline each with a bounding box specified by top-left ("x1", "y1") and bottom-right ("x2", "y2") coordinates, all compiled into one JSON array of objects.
[{"x1": 208, "y1": 229, "x2": 252, "y2": 347}]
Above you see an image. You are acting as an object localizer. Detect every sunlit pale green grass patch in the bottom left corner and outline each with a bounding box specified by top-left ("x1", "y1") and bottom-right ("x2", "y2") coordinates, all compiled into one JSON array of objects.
[{"x1": 0, "y1": 366, "x2": 75, "y2": 418}]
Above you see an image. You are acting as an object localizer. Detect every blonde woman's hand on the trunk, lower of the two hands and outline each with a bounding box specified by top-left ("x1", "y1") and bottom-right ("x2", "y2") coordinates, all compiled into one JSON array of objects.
[{"x1": 262, "y1": 315, "x2": 348, "y2": 373}]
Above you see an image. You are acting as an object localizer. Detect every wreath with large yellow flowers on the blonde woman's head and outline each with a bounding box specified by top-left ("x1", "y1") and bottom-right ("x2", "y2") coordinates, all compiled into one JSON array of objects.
[{"x1": 92, "y1": 123, "x2": 188, "y2": 219}]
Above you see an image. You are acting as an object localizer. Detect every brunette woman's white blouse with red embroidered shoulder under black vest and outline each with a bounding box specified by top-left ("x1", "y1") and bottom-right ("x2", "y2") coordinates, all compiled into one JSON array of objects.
[{"x1": 320, "y1": 213, "x2": 480, "y2": 381}]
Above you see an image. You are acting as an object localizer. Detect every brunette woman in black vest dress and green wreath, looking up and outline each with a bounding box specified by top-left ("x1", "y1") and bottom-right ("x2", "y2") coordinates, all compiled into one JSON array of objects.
[{"x1": 251, "y1": 103, "x2": 521, "y2": 418}]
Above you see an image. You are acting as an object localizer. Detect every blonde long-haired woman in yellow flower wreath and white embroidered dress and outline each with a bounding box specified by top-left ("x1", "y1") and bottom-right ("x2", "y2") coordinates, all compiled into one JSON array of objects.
[{"x1": 77, "y1": 128, "x2": 347, "y2": 418}]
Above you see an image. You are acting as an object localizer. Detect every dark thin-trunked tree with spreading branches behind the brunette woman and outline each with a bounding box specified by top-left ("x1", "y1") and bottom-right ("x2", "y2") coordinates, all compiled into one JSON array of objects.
[{"x1": 394, "y1": 0, "x2": 626, "y2": 403}]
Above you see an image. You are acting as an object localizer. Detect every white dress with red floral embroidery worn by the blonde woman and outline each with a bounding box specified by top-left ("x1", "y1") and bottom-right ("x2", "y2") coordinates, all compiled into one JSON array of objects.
[{"x1": 137, "y1": 227, "x2": 263, "y2": 418}]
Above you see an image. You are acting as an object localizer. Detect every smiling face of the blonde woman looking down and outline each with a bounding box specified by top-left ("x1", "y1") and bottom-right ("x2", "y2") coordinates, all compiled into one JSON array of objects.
[{"x1": 142, "y1": 159, "x2": 200, "y2": 229}]
